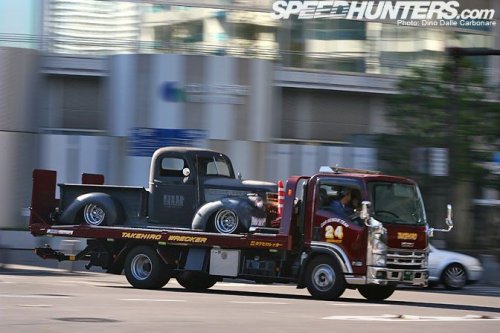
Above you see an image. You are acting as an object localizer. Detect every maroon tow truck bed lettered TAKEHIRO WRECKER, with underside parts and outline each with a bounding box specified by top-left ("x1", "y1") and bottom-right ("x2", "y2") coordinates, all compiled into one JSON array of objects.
[{"x1": 30, "y1": 222, "x2": 293, "y2": 284}]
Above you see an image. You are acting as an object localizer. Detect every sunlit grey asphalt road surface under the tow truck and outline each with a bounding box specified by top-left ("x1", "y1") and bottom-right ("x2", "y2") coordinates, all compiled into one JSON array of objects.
[{"x1": 0, "y1": 266, "x2": 500, "y2": 333}]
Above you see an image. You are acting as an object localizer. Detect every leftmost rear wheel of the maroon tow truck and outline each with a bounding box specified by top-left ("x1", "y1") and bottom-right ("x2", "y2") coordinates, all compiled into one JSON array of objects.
[{"x1": 124, "y1": 246, "x2": 170, "y2": 289}]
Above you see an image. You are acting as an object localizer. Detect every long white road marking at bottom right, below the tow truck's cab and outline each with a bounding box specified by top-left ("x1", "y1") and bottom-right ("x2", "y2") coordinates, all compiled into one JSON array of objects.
[{"x1": 322, "y1": 314, "x2": 500, "y2": 322}]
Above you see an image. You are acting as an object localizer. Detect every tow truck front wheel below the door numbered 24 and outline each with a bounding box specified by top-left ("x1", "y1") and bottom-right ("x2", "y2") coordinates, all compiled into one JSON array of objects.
[{"x1": 305, "y1": 255, "x2": 346, "y2": 301}]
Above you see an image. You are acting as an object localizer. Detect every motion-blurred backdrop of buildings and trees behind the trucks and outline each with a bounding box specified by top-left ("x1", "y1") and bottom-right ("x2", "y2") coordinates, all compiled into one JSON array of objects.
[{"x1": 0, "y1": 0, "x2": 500, "y2": 254}]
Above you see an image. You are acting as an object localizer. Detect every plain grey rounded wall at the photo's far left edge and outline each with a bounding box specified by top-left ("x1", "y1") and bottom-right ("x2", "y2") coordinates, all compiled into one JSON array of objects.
[{"x1": 0, "y1": 47, "x2": 39, "y2": 228}]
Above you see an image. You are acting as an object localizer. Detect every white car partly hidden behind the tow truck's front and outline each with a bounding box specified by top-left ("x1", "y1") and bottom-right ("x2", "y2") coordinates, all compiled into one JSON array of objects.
[{"x1": 429, "y1": 245, "x2": 483, "y2": 289}]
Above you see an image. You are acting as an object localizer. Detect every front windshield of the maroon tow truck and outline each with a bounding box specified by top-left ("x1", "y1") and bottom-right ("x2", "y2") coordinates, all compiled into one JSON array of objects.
[{"x1": 368, "y1": 182, "x2": 427, "y2": 225}]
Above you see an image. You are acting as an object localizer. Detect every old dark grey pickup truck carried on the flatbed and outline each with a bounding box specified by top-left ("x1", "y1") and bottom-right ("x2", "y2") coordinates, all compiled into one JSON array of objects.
[{"x1": 32, "y1": 147, "x2": 277, "y2": 234}]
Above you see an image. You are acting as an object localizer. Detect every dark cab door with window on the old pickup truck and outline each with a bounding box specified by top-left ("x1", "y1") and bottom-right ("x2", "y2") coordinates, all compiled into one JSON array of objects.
[{"x1": 149, "y1": 154, "x2": 197, "y2": 228}]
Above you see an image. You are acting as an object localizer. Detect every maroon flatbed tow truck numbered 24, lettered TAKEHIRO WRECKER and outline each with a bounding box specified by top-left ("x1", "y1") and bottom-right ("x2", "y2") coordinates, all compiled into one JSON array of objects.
[{"x1": 29, "y1": 147, "x2": 453, "y2": 301}]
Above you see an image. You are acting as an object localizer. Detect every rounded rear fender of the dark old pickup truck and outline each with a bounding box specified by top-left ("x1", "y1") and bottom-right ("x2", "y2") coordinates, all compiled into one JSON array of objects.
[{"x1": 58, "y1": 192, "x2": 124, "y2": 225}]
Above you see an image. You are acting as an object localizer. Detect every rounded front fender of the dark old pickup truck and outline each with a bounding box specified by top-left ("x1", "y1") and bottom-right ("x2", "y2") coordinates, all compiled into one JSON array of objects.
[{"x1": 191, "y1": 196, "x2": 266, "y2": 230}]
